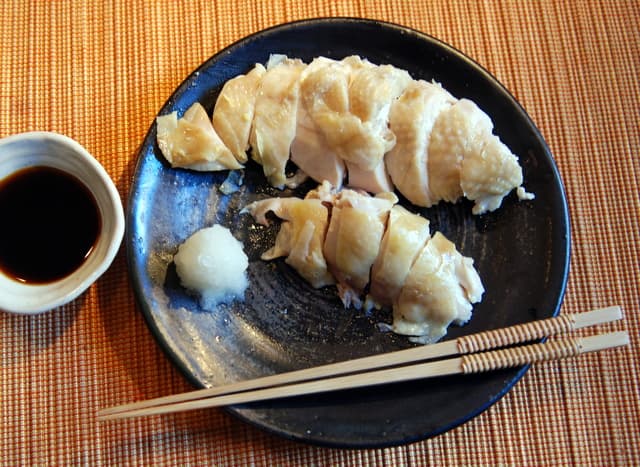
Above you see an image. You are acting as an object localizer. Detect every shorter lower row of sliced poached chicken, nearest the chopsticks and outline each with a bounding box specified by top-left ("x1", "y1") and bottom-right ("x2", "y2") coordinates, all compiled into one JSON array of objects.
[{"x1": 243, "y1": 182, "x2": 484, "y2": 343}]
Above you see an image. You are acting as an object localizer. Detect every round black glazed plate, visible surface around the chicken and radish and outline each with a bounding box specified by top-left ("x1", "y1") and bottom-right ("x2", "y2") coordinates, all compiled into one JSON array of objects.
[{"x1": 126, "y1": 19, "x2": 570, "y2": 448}]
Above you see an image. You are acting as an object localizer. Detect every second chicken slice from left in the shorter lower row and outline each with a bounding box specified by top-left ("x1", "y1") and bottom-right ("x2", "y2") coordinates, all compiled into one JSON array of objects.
[{"x1": 323, "y1": 190, "x2": 398, "y2": 309}]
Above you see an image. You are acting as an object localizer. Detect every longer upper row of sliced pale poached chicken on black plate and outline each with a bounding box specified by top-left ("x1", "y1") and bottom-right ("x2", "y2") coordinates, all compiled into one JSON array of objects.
[{"x1": 158, "y1": 55, "x2": 534, "y2": 214}]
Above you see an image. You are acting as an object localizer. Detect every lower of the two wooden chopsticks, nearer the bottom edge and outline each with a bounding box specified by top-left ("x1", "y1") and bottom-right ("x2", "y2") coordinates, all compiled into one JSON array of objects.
[{"x1": 98, "y1": 331, "x2": 629, "y2": 420}]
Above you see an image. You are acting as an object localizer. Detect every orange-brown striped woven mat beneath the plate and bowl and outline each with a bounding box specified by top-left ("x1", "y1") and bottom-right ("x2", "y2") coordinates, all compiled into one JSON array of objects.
[{"x1": 0, "y1": 0, "x2": 640, "y2": 466}]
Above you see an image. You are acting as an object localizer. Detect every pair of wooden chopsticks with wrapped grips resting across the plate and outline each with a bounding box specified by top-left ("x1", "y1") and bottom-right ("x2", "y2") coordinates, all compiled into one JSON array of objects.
[{"x1": 98, "y1": 306, "x2": 629, "y2": 420}]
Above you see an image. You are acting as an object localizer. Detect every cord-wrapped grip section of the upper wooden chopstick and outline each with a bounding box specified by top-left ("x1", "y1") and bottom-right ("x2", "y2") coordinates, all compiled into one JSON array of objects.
[{"x1": 456, "y1": 315, "x2": 575, "y2": 354}]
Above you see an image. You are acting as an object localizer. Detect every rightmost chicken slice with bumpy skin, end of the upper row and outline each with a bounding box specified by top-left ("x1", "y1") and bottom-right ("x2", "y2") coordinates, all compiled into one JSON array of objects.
[{"x1": 460, "y1": 134, "x2": 533, "y2": 214}]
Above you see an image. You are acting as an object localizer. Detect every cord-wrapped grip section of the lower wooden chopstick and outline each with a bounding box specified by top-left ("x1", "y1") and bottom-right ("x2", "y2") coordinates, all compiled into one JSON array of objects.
[{"x1": 461, "y1": 338, "x2": 581, "y2": 373}]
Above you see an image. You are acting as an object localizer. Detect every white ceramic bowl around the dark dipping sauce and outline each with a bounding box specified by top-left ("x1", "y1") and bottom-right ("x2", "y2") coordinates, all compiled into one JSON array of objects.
[{"x1": 0, "y1": 132, "x2": 124, "y2": 314}]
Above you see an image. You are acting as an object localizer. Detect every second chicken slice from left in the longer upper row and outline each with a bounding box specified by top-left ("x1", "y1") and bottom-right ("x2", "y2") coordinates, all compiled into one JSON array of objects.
[{"x1": 212, "y1": 63, "x2": 266, "y2": 163}]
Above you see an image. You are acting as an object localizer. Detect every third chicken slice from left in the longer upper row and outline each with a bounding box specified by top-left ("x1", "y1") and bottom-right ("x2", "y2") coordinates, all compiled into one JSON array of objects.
[{"x1": 249, "y1": 56, "x2": 306, "y2": 189}]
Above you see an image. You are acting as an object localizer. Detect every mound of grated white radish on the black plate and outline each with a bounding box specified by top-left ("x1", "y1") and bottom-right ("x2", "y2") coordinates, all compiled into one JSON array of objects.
[{"x1": 174, "y1": 225, "x2": 249, "y2": 309}]
